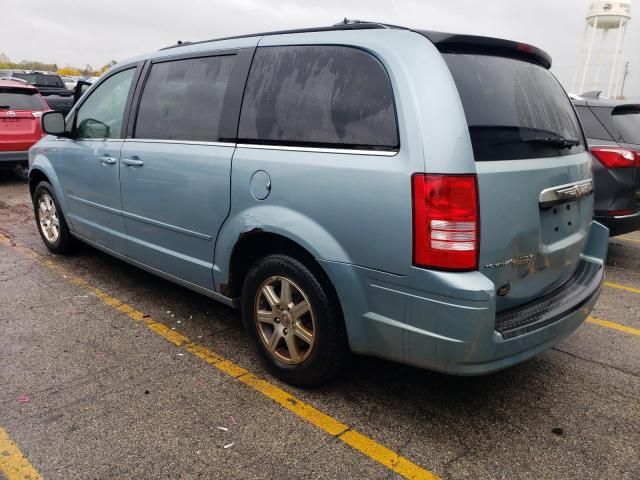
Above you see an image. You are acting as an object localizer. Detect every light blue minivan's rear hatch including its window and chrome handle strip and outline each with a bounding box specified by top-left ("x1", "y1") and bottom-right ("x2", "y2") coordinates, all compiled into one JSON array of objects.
[{"x1": 441, "y1": 40, "x2": 593, "y2": 311}]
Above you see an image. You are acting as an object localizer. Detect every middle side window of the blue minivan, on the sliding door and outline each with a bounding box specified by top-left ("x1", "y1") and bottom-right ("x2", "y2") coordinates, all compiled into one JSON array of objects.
[{"x1": 134, "y1": 55, "x2": 236, "y2": 142}]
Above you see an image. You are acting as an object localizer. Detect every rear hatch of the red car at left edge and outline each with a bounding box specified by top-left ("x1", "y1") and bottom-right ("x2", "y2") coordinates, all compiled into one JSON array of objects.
[{"x1": 0, "y1": 87, "x2": 48, "y2": 152}]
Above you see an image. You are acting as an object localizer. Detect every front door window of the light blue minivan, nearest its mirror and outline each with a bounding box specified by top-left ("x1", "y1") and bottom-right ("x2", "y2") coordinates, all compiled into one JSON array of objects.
[{"x1": 76, "y1": 68, "x2": 136, "y2": 138}]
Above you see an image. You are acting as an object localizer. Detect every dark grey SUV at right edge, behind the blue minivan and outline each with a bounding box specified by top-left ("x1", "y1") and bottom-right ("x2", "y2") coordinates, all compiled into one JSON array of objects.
[{"x1": 572, "y1": 92, "x2": 640, "y2": 236}]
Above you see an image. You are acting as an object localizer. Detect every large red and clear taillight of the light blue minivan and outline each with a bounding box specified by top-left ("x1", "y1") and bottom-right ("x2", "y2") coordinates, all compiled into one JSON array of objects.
[{"x1": 412, "y1": 173, "x2": 480, "y2": 270}]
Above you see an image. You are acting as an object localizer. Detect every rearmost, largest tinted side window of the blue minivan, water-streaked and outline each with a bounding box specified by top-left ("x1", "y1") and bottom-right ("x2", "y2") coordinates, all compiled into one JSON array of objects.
[{"x1": 238, "y1": 46, "x2": 399, "y2": 150}]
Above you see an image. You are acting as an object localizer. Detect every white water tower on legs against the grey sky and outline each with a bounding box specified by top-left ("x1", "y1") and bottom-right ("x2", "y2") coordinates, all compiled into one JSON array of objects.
[{"x1": 571, "y1": 0, "x2": 631, "y2": 97}]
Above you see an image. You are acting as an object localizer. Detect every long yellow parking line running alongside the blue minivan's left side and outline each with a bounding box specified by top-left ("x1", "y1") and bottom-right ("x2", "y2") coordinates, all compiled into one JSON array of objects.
[{"x1": 0, "y1": 234, "x2": 438, "y2": 480}]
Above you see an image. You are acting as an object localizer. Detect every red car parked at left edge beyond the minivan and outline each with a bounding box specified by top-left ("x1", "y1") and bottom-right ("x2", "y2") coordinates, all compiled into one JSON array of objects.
[{"x1": 0, "y1": 79, "x2": 51, "y2": 167}]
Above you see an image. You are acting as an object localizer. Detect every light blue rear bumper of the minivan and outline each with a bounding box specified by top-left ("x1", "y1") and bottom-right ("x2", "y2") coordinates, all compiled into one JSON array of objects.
[{"x1": 323, "y1": 223, "x2": 608, "y2": 375}]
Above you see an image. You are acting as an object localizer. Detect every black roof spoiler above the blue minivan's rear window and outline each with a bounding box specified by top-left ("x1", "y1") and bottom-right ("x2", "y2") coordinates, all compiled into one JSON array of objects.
[{"x1": 415, "y1": 30, "x2": 551, "y2": 69}]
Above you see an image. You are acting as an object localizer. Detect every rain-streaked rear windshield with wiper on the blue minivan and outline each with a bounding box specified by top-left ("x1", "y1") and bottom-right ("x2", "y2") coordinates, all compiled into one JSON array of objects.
[{"x1": 443, "y1": 53, "x2": 585, "y2": 161}]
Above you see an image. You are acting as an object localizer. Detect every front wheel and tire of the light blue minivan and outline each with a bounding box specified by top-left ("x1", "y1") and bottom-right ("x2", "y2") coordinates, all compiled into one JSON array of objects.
[{"x1": 32, "y1": 181, "x2": 76, "y2": 254}]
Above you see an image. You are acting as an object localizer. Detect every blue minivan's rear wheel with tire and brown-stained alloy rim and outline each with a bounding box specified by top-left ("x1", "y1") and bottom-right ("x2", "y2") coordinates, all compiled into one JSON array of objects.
[{"x1": 242, "y1": 254, "x2": 348, "y2": 387}]
